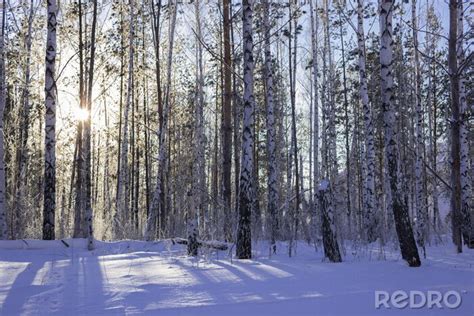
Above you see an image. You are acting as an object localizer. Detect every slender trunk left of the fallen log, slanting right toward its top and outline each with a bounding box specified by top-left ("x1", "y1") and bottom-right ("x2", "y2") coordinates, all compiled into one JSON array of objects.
[{"x1": 145, "y1": 1, "x2": 177, "y2": 240}]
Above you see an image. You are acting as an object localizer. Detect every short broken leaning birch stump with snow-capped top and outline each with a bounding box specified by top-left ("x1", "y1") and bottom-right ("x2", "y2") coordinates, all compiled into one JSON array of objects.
[{"x1": 318, "y1": 179, "x2": 342, "y2": 262}]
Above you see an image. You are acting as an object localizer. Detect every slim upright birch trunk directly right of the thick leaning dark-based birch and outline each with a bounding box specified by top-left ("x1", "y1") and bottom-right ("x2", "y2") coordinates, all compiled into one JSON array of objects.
[{"x1": 411, "y1": 0, "x2": 428, "y2": 251}]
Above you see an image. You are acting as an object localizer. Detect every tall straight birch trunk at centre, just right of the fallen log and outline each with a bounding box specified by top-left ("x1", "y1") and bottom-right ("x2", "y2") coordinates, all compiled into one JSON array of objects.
[{"x1": 236, "y1": 0, "x2": 255, "y2": 259}]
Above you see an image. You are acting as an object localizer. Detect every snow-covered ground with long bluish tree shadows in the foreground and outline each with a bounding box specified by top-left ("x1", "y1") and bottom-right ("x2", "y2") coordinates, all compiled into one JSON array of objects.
[{"x1": 0, "y1": 240, "x2": 474, "y2": 316}]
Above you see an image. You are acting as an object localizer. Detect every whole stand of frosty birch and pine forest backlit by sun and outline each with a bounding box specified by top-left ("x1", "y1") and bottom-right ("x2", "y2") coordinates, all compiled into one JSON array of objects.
[{"x1": 0, "y1": 0, "x2": 474, "y2": 265}]
